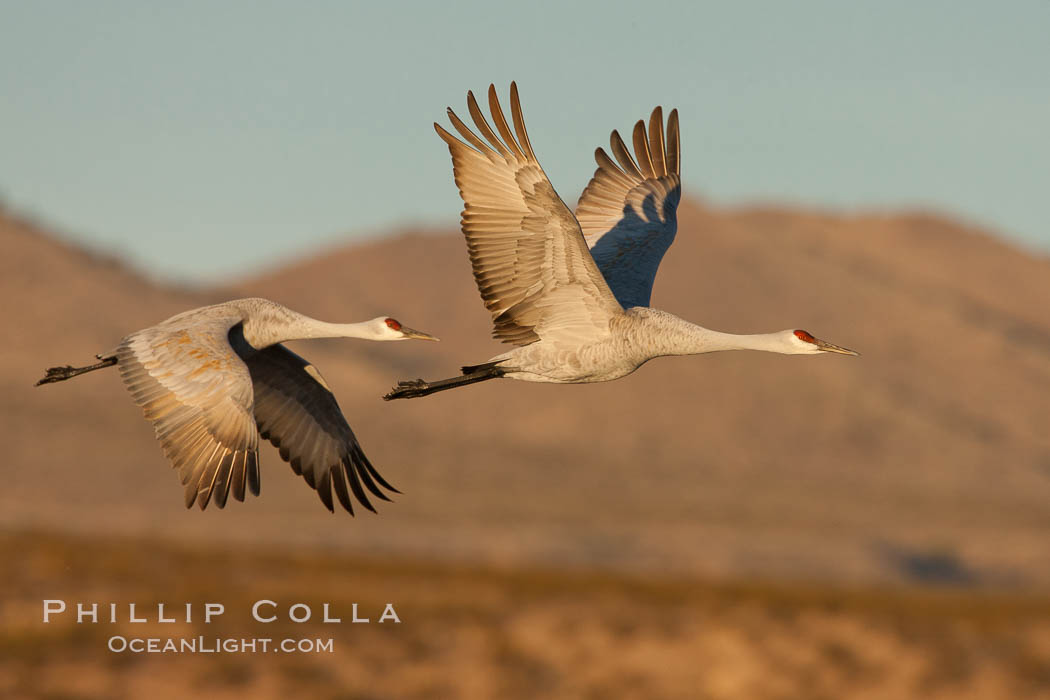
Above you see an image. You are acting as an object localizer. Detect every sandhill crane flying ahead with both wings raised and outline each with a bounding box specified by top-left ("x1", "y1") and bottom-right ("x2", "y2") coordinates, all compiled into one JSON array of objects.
[{"x1": 383, "y1": 83, "x2": 857, "y2": 400}]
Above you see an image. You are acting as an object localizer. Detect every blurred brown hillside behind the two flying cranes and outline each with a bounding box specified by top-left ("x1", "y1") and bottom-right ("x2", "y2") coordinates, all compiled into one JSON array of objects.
[{"x1": 0, "y1": 204, "x2": 1050, "y2": 585}]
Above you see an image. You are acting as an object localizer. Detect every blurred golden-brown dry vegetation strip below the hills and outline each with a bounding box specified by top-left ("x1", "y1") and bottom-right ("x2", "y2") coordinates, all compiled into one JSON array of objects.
[{"x1": 6, "y1": 533, "x2": 1050, "y2": 700}]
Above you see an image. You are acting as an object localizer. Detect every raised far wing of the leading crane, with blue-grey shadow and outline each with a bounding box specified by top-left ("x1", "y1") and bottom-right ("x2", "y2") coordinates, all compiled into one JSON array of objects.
[{"x1": 576, "y1": 107, "x2": 681, "y2": 309}]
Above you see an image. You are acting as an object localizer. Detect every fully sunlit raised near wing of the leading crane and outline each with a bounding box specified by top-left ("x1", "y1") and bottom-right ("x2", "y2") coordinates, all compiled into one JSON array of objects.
[{"x1": 434, "y1": 83, "x2": 622, "y2": 345}]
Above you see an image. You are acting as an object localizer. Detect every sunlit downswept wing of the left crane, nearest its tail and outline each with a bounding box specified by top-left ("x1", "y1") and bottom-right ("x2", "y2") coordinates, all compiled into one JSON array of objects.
[{"x1": 116, "y1": 306, "x2": 259, "y2": 510}]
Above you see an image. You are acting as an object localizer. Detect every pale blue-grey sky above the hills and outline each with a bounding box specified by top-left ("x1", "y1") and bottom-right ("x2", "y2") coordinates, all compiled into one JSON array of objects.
[{"x1": 0, "y1": 0, "x2": 1050, "y2": 282}]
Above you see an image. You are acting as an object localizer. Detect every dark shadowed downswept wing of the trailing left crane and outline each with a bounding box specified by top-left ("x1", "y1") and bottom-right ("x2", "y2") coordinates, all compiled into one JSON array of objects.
[{"x1": 246, "y1": 345, "x2": 398, "y2": 515}]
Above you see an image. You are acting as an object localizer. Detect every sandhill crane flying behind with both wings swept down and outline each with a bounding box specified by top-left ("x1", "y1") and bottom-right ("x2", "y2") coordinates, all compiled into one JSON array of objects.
[{"x1": 37, "y1": 298, "x2": 437, "y2": 515}]
